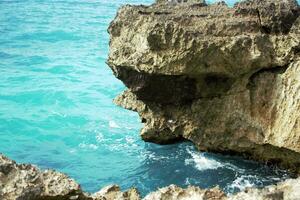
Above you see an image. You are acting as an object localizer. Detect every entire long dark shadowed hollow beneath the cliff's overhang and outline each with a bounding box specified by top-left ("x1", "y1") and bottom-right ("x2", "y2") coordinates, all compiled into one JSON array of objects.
[{"x1": 113, "y1": 67, "x2": 239, "y2": 105}]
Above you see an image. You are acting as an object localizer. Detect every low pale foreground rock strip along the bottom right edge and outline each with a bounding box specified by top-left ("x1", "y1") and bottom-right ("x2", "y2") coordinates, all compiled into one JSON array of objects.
[{"x1": 144, "y1": 178, "x2": 300, "y2": 200}]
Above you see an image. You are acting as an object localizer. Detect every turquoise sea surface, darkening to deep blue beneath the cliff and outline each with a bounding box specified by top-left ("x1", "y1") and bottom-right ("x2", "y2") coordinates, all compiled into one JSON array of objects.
[{"x1": 0, "y1": 0, "x2": 296, "y2": 195}]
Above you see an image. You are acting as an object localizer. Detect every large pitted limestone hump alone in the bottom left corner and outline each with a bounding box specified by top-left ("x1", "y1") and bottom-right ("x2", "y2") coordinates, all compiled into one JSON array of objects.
[{"x1": 0, "y1": 155, "x2": 83, "y2": 200}]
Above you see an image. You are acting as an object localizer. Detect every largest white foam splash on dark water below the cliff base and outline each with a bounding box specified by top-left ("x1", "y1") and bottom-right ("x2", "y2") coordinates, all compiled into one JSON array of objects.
[{"x1": 185, "y1": 149, "x2": 224, "y2": 171}]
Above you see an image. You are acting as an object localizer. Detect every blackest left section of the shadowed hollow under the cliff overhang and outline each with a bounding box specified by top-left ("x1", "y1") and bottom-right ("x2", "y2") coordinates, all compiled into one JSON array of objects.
[{"x1": 114, "y1": 67, "x2": 196, "y2": 105}]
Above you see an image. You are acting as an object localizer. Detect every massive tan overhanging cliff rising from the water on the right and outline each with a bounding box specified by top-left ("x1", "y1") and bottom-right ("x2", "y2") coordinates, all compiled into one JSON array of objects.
[{"x1": 107, "y1": 0, "x2": 300, "y2": 172}]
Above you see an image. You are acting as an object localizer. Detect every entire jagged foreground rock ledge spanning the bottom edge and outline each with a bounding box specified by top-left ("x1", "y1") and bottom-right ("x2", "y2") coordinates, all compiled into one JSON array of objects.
[{"x1": 0, "y1": 154, "x2": 300, "y2": 200}]
